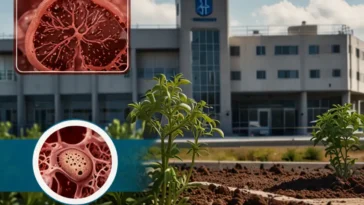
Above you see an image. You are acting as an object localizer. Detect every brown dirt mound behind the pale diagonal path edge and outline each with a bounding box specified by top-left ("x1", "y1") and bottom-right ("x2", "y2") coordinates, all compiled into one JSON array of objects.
[{"x1": 188, "y1": 165, "x2": 364, "y2": 199}]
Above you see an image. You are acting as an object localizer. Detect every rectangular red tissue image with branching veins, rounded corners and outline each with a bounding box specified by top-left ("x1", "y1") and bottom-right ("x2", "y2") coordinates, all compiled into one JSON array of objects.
[{"x1": 15, "y1": 0, "x2": 130, "y2": 73}]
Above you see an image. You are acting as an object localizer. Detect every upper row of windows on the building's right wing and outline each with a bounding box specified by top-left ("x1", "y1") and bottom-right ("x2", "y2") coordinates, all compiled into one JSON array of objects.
[{"x1": 230, "y1": 45, "x2": 342, "y2": 57}]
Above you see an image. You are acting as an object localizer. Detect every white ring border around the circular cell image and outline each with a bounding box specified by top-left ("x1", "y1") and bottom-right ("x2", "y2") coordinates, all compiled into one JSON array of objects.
[{"x1": 33, "y1": 120, "x2": 118, "y2": 205}]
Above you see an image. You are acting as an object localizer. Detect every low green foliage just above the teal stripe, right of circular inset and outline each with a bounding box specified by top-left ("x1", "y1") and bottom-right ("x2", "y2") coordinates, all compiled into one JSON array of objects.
[{"x1": 106, "y1": 119, "x2": 145, "y2": 139}]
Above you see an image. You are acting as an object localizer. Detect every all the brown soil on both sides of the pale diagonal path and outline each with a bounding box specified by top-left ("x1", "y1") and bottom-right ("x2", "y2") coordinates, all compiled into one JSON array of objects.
[{"x1": 181, "y1": 164, "x2": 364, "y2": 205}]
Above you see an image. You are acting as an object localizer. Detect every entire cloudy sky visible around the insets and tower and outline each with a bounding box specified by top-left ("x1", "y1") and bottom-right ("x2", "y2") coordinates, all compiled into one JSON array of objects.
[{"x1": 0, "y1": 0, "x2": 364, "y2": 40}]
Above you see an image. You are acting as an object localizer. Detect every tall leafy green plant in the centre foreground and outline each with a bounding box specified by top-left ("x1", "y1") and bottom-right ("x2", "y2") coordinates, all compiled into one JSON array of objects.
[{"x1": 128, "y1": 74, "x2": 223, "y2": 205}]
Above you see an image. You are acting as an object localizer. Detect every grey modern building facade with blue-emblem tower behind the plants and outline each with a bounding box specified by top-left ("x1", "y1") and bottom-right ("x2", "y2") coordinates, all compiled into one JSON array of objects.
[{"x1": 0, "y1": 0, "x2": 364, "y2": 136}]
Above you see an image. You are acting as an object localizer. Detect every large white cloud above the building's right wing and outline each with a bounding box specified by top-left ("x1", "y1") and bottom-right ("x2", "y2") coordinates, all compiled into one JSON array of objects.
[{"x1": 255, "y1": 0, "x2": 364, "y2": 37}]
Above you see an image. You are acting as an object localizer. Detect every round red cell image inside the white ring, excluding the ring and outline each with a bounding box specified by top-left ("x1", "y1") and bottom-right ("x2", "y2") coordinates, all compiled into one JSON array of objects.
[{"x1": 38, "y1": 126, "x2": 112, "y2": 199}]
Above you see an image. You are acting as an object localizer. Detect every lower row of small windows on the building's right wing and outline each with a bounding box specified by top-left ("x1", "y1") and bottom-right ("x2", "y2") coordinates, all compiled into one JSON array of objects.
[{"x1": 231, "y1": 69, "x2": 342, "y2": 80}]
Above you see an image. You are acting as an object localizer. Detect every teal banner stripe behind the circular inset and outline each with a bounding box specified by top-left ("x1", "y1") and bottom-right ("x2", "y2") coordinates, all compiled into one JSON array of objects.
[{"x1": 0, "y1": 140, "x2": 155, "y2": 192}]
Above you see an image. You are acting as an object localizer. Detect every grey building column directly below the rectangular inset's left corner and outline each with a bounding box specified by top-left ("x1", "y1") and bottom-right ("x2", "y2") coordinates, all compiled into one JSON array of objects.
[{"x1": 16, "y1": 75, "x2": 25, "y2": 136}]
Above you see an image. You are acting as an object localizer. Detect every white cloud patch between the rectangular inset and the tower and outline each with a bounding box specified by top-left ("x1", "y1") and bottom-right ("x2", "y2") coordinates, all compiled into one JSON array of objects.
[{"x1": 131, "y1": 0, "x2": 176, "y2": 25}]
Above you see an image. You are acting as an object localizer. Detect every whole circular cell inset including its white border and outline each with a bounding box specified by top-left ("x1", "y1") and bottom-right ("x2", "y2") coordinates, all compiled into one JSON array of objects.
[{"x1": 33, "y1": 120, "x2": 118, "y2": 204}]
